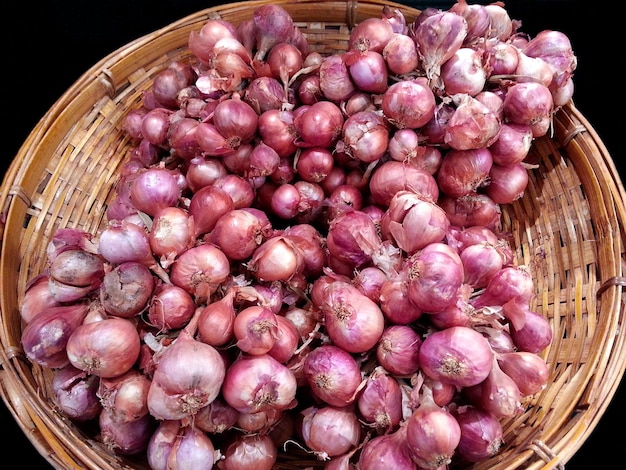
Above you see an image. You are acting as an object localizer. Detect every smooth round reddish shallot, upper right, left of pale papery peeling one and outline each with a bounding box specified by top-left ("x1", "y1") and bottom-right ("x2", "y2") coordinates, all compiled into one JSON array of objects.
[{"x1": 381, "y1": 80, "x2": 436, "y2": 129}]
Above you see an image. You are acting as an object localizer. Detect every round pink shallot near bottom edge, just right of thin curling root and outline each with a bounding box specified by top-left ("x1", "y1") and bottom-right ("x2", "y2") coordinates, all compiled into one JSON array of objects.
[{"x1": 299, "y1": 406, "x2": 361, "y2": 460}]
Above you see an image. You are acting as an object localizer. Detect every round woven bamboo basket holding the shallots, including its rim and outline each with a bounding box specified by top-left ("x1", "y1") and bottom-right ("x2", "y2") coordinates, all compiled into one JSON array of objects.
[{"x1": 0, "y1": 0, "x2": 626, "y2": 470}]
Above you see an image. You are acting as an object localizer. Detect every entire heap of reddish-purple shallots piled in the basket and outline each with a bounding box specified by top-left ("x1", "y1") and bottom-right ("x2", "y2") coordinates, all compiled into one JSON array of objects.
[{"x1": 21, "y1": 0, "x2": 576, "y2": 470}]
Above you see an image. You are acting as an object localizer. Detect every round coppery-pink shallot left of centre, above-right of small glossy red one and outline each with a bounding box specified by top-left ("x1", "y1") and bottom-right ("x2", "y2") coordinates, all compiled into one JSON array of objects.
[{"x1": 170, "y1": 244, "x2": 230, "y2": 303}]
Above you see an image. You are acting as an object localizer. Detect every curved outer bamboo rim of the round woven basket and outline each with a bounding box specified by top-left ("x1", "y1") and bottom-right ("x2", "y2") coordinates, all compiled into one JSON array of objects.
[{"x1": 0, "y1": 0, "x2": 626, "y2": 468}]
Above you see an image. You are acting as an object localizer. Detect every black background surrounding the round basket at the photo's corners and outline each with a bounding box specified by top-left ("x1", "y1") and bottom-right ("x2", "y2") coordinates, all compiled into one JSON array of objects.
[{"x1": 0, "y1": 0, "x2": 626, "y2": 470}]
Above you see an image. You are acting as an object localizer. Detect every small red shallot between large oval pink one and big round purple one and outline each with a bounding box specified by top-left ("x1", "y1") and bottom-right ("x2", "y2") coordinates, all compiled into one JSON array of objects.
[{"x1": 376, "y1": 325, "x2": 422, "y2": 376}]
